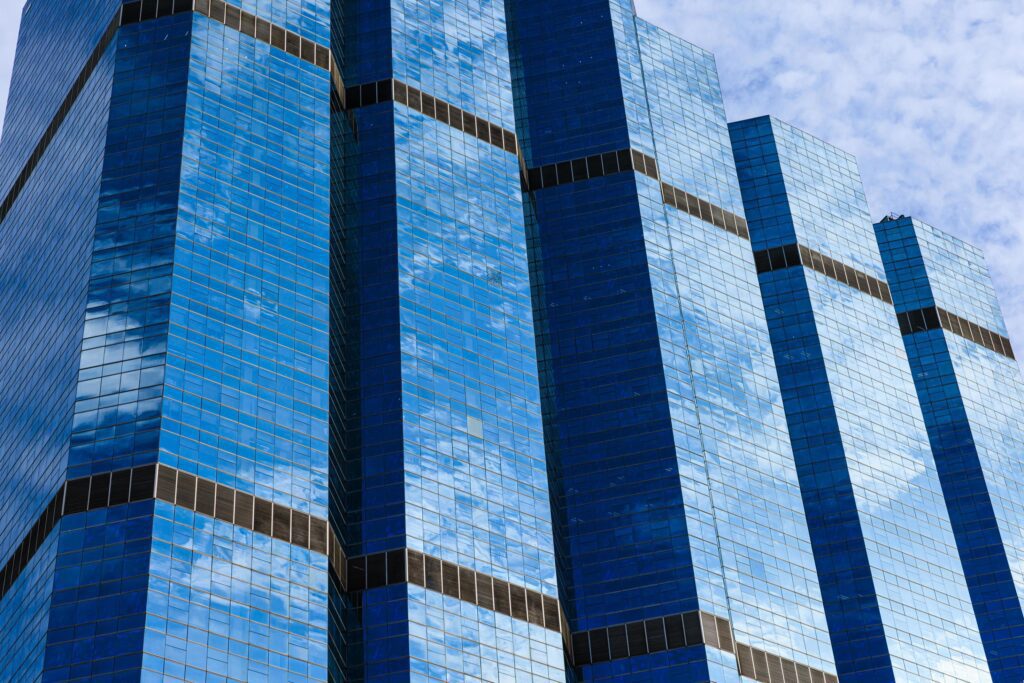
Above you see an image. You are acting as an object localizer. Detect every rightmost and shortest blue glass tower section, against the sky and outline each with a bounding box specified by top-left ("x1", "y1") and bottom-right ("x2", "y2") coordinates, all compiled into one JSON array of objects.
[{"x1": 874, "y1": 216, "x2": 1024, "y2": 683}]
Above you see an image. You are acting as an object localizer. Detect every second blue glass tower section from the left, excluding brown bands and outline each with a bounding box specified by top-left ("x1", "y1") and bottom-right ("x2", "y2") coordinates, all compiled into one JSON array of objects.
[{"x1": 335, "y1": 0, "x2": 565, "y2": 681}]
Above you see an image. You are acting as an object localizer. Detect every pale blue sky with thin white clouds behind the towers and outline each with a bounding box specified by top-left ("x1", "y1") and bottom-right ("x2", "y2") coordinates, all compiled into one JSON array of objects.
[{"x1": 0, "y1": 0, "x2": 1024, "y2": 347}]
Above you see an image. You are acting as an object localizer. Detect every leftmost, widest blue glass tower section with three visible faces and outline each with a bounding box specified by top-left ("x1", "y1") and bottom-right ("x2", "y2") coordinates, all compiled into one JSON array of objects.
[{"x1": 3, "y1": 2, "x2": 331, "y2": 680}]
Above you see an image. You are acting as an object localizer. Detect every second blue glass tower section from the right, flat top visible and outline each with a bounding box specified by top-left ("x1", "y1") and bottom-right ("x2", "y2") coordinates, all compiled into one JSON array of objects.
[{"x1": 730, "y1": 118, "x2": 988, "y2": 682}]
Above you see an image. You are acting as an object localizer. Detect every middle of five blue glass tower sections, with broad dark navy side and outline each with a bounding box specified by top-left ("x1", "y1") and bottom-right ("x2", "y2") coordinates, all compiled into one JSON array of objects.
[{"x1": 507, "y1": 1, "x2": 835, "y2": 681}]
